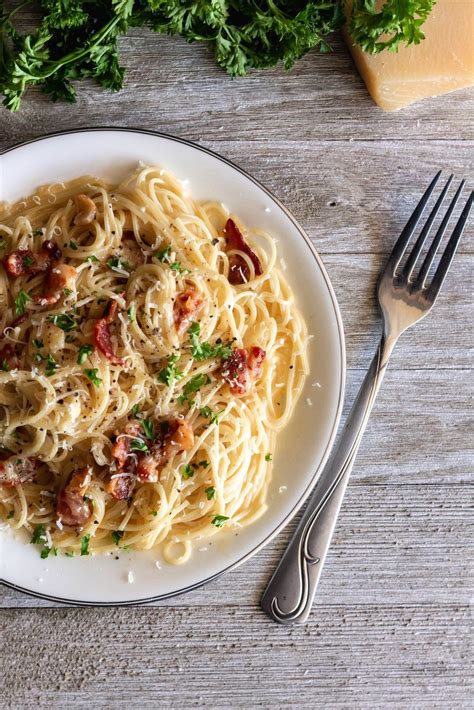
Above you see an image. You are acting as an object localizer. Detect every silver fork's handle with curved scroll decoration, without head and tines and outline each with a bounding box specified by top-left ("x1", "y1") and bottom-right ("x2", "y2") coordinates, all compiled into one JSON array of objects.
[{"x1": 261, "y1": 336, "x2": 395, "y2": 624}]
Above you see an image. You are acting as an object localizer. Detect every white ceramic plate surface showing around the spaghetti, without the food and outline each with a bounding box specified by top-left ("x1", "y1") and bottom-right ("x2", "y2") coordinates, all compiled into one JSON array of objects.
[{"x1": 0, "y1": 129, "x2": 345, "y2": 604}]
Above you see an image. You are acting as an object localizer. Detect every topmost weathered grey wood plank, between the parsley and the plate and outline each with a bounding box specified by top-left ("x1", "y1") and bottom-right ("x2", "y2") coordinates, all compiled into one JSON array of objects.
[{"x1": 0, "y1": 30, "x2": 474, "y2": 142}]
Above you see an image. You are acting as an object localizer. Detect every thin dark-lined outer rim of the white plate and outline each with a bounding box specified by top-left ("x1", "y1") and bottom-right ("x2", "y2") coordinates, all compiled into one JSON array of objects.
[{"x1": 0, "y1": 126, "x2": 347, "y2": 607}]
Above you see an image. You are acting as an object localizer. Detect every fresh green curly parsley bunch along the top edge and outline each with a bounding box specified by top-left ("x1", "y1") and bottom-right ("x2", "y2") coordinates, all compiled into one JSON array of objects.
[{"x1": 0, "y1": 0, "x2": 435, "y2": 111}]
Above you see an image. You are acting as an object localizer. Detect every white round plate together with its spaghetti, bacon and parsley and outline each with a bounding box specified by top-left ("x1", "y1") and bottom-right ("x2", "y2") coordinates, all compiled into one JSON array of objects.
[{"x1": 0, "y1": 129, "x2": 345, "y2": 604}]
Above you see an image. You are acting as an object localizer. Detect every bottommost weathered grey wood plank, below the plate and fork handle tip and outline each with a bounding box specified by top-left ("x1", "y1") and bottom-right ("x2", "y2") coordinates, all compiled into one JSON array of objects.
[{"x1": 2, "y1": 600, "x2": 470, "y2": 708}]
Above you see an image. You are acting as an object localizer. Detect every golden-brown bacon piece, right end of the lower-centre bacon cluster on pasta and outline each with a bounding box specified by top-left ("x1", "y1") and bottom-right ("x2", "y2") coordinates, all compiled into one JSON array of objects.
[{"x1": 135, "y1": 419, "x2": 194, "y2": 483}]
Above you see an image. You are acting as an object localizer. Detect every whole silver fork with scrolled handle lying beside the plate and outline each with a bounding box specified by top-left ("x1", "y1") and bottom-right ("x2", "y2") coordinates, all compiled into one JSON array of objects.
[{"x1": 262, "y1": 171, "x2": 474, "y2": 624}]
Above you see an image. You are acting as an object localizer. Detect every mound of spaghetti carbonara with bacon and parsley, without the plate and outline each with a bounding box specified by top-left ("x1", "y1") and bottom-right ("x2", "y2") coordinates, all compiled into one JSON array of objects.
[{"x1": 0, "y1": 166, "x2": 307, "y2": 563}]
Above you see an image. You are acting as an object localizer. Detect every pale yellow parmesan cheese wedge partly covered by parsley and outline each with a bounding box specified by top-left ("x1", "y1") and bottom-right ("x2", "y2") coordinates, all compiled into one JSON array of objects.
[{"x1": 345, "y1": 0, "x2": 474, "y2": 111}]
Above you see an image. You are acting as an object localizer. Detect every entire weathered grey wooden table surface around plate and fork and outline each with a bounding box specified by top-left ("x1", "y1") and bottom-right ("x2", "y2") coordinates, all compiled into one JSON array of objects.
[{"x1": 0, "y1": 31, "x2": 474, "y2": 710}]
